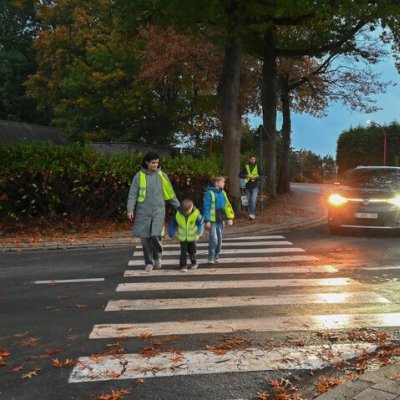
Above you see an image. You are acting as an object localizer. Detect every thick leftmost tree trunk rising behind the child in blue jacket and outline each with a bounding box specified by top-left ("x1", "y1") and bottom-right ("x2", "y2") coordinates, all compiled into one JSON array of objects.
[{"x1": 220, "y1": 38, "x2": 242, "y2": 203}]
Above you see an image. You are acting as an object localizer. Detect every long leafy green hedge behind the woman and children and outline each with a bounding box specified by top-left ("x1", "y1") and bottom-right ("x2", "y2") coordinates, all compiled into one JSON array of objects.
[{"x1": 0, "y1": 142, "x2": 221, "y2": 220}]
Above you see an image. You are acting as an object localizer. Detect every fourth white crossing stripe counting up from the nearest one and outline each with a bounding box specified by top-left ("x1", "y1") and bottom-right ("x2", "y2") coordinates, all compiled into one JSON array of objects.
[{"x1": 117, "y1": 278, "x2": 360, "y2": 292}]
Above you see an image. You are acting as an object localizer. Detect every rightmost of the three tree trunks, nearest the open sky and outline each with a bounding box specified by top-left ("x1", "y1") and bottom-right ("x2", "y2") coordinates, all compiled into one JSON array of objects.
[{"x1": 277, "y1": 74, "x2": 291, "y2": 194}]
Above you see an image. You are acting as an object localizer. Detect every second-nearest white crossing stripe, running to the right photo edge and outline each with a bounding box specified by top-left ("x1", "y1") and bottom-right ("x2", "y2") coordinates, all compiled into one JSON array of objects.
[{"x1": 89, "y1": 313, "x2": 400, "y2": 339}]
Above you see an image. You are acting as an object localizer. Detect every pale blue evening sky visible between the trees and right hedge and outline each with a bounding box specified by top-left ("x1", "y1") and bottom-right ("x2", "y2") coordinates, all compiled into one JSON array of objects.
[{"x1": 250, "y1": 57, "x2": 400, "y2": 158}]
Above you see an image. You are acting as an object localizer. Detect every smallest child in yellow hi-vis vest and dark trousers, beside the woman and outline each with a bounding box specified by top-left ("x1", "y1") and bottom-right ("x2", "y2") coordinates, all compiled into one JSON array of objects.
[{"x1": 168, "y1": 199, "x2": 204, "y2": 272}]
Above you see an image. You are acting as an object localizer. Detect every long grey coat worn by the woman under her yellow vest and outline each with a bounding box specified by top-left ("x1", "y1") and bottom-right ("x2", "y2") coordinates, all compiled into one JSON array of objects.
[{"x1": 127, "y1": 168, "x2": 180, "y2": 238}]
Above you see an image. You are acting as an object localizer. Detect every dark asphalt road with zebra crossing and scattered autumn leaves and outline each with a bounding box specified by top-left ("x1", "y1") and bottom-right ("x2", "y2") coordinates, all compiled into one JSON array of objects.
[{"x1": 0, "y1": 212, "x2": 400, "y2": 400}]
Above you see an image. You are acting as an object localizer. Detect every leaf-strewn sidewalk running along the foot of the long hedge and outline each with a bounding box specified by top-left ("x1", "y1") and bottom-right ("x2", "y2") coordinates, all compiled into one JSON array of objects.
[{"x1": 0, "y1": 190, "x2": 326, "y2": 253}]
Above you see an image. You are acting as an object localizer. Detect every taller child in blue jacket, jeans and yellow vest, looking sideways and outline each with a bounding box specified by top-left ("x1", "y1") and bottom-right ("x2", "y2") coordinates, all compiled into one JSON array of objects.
[{"x1": 203, "y1": 175, "x2": 235, "y2": 264}]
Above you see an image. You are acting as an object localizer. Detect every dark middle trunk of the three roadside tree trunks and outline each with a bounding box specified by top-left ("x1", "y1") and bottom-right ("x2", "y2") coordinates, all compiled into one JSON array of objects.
[{"x1": 261, "y1": 28, "x2": 277, "y2": 198}]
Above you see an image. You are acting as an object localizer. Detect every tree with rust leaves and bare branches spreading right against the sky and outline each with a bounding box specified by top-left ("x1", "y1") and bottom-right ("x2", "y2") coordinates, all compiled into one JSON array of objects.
[{"x1": 277, "y1": 44, "x2": 390, "y2": 193}]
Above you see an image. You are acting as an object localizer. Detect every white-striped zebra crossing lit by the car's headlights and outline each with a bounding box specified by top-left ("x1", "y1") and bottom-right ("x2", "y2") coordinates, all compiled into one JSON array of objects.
[{"x1": 69, "y1": 235, "x2": 394, "y2": 383}]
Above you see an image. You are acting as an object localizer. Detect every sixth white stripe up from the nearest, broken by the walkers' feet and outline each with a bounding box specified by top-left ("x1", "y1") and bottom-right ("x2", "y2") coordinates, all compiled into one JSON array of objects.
[{"x1": 128, "y1": 255, "x2": 318, "y2": 267}]
